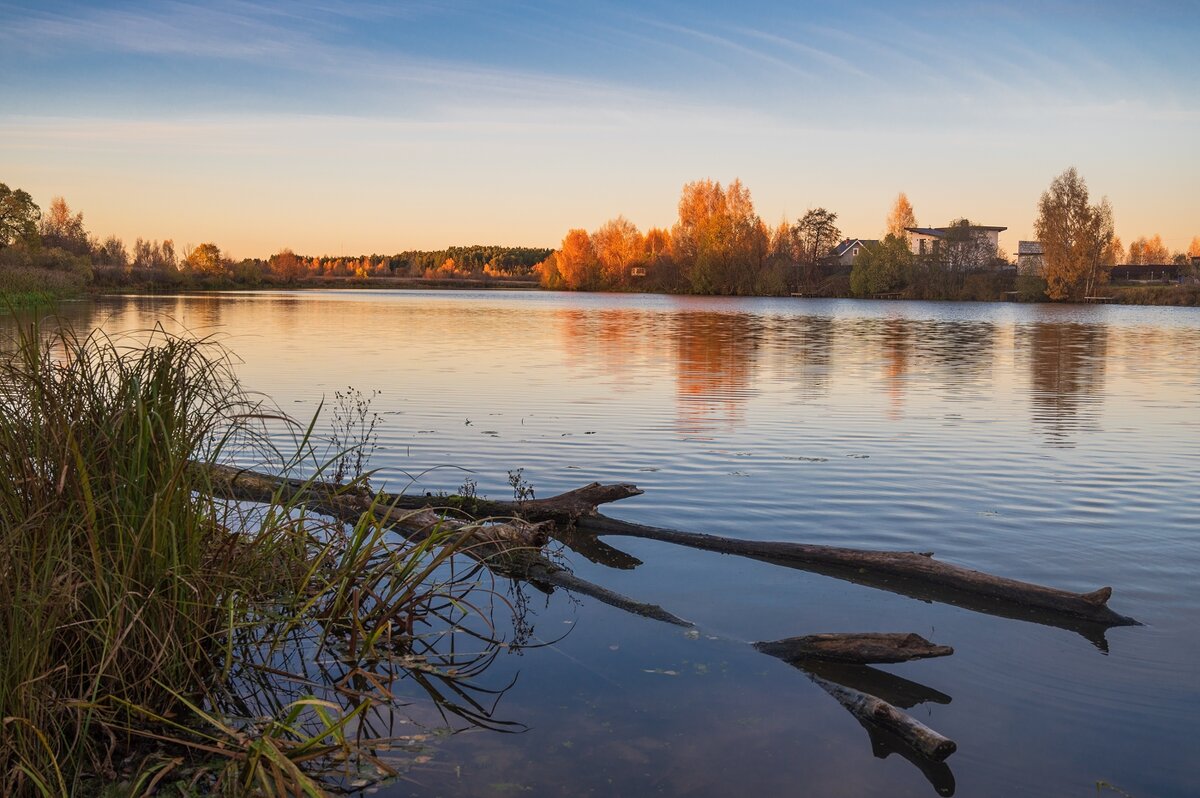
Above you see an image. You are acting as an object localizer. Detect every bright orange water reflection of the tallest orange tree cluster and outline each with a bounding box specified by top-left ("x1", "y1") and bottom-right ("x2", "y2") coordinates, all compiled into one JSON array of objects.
[{"x1": 672, "y1": 313, "x2": 763, "y2": 434}]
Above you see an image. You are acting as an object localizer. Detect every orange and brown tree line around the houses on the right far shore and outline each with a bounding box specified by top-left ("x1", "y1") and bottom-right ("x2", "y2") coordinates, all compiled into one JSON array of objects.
[{"x1": 535, "y1": 168, "x2": 1200, "y2": 300}]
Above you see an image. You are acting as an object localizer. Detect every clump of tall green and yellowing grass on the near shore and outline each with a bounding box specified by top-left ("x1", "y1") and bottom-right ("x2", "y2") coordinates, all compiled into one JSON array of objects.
[{"x1": 0, "y1": 328, "x2": 501, "y2": 796}]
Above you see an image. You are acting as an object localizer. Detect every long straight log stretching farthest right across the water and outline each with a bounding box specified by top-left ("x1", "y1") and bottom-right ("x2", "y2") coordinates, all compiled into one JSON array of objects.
[{"x1": 577, "y1": 515, "x2": 1140, "y2": 626}]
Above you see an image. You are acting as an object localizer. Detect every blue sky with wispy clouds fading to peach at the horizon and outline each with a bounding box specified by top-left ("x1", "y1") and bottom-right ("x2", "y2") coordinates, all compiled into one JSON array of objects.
[{"x1": 0, "y1": 0, "x2": 1200, "y2": 258}]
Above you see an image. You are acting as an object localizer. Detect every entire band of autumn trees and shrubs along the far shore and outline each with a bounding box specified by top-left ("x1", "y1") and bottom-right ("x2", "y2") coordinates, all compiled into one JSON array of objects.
[{"x1": 7, "y1": 177, "x2": 1200, "y2": 305}]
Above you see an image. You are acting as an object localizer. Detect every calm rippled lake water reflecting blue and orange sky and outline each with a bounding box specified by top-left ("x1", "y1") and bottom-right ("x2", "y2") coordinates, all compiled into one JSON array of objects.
[{"x1": 18, "y1": 292, "x2": 1200, "y2": 798}]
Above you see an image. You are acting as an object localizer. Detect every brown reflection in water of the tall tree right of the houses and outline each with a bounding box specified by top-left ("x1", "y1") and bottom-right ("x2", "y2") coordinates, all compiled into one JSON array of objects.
[{"x1": 1020, "y1": 324, "x2": 1109, "y2": 446}]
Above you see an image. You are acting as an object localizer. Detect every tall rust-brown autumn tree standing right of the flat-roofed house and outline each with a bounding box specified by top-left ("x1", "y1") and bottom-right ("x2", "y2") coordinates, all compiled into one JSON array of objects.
[{"x1": 1033, "y1": 167, "x2": 1113, "y2": 300}]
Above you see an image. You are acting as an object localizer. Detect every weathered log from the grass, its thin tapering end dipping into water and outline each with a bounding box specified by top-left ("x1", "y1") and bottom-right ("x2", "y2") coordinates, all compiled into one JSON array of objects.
[{"x1": 201, "y1": 463, "x2": 692, "y2": 626}]
